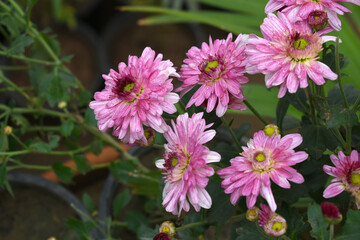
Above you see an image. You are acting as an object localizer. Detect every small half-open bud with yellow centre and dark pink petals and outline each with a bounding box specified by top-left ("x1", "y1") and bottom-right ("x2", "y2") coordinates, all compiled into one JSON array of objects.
[{"x1": 259, "y1": 203, "x2": 287, "y2": 237}]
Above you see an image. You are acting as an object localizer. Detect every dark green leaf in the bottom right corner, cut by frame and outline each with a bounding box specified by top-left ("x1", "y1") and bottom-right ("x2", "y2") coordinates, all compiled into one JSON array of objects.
[{"x1": 336, "y1": 209, "x2": 360, "y2": 240}]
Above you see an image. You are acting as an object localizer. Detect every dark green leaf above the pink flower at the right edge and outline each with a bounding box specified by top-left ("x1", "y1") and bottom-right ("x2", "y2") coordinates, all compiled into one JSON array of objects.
[{"x1": 326, "y1": 106, "x2": 359, "y2": 128}]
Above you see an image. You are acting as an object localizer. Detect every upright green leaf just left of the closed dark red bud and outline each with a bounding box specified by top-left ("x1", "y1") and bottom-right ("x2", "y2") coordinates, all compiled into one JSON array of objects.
[{"x1": 307, "y1": 204, "x2": 329, "y2": 240}]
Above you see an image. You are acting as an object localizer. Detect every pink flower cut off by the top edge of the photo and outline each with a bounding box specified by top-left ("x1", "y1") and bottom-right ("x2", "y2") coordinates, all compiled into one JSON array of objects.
[{"x1": 265, "y1": 0, "x2": 360, "y2": 31}]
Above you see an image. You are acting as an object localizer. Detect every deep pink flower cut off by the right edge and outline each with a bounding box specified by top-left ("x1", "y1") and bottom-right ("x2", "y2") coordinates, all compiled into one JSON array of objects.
[{"x1": 323, "y1": 150, "x2": 360, "y2": 208}]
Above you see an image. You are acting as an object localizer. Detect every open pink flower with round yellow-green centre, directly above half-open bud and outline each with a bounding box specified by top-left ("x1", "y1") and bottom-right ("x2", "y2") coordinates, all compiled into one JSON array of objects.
[{"x1": 217, "y1": 131, "x2": 308, "y2": 211}]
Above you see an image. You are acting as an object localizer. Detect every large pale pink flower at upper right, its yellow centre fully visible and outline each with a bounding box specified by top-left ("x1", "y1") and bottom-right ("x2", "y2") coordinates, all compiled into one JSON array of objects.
[{"x1": 245, "y1": 12, "x2": 337, "y2": 98}]
